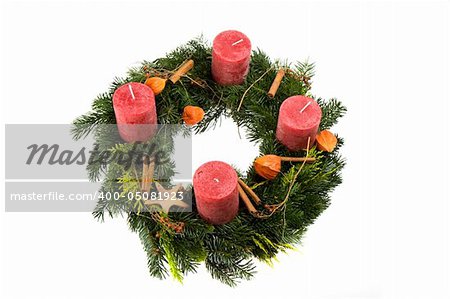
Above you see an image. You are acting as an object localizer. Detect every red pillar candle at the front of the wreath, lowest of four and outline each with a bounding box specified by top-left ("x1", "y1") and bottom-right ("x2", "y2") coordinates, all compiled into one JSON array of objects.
[{"x1": 193, "y1": 161, "x2": 239, "y2": 224}]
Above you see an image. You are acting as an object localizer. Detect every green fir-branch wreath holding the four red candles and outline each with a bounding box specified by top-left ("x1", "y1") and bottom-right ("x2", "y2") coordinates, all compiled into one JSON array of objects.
[{"x1": 72, "y1": 38, "x2": 346, "y2": 286}]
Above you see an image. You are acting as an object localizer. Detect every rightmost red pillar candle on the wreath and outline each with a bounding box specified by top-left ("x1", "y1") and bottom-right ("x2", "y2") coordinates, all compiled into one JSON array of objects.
[{"x1": 276, "y1": 96, "x2": 322, "y2": 151}]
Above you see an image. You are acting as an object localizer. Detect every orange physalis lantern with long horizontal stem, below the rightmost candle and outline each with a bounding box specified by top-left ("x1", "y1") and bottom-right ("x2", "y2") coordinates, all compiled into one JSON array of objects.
[{"x1": 253, "y1": 155, "x2": 316, "y2": 180}]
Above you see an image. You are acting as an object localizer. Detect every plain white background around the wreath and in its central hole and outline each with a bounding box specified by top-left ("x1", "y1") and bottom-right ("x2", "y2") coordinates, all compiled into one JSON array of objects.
[{"x1": 0, "y1": 0, "x2": 450, "y2": 298}]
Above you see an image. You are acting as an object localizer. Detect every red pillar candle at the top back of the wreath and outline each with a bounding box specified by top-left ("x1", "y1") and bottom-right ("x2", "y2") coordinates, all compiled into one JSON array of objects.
[{"x1": 211, "y1": 30, "x2": 252, "y2": 85}]
